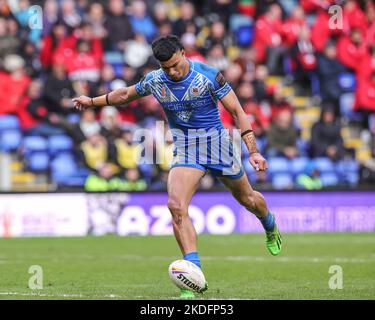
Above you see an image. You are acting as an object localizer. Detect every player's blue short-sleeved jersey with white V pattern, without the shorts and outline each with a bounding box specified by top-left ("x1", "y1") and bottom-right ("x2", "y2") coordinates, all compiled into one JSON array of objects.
[{"x1": 135, "y1": 60, "x2": 231, "y2": 133}]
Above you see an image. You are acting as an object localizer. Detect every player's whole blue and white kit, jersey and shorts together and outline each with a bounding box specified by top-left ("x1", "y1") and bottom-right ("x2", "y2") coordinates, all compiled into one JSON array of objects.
[{"x1": 135, "y1": 60, "x2": 244, "y2": 180}]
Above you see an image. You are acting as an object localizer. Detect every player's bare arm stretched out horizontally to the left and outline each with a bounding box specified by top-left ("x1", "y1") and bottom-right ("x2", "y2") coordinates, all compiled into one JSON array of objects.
[{"x1": 72, "y1": 85, "x2": 141, "y2": 110}]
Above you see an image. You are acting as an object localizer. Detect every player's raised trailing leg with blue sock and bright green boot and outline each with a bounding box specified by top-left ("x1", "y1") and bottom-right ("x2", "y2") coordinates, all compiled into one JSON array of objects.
[{"x1": 219, "y1": 174, "x2": 282, "y2": 255}]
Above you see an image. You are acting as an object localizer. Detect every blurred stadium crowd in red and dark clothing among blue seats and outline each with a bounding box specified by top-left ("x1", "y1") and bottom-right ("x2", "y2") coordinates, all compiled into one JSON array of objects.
[{"x1": 0, "y1": 0, "x2": 375, "y2": 191}]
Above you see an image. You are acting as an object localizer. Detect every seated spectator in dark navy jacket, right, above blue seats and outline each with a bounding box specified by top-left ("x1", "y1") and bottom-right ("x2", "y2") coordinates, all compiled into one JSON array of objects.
[{"x1": 311, "y1": 105, "x2": 344, "y2": 161}]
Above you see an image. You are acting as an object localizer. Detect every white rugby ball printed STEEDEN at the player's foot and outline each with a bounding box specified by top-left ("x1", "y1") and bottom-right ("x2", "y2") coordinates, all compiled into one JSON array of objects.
[{"x1": 168, "y1": 260, "x2": 206, "y2": 293}]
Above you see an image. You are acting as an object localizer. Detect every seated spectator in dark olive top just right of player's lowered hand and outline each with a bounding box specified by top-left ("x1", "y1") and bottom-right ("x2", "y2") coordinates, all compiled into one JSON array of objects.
[{"x1": 267, "y1": 109, "x2": 298, "y2": 159}]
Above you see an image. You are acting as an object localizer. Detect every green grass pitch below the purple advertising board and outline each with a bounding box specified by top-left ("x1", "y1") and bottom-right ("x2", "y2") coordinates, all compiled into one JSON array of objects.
[{"x1": 0, "y1": 233, "x2": 375, "y2": 299}]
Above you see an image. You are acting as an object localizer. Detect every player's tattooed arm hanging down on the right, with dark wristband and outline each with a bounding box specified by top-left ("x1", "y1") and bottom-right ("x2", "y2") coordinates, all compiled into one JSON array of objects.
[{"x1": 221, "y1": 90, "x2": 268, "y2": 171}]
